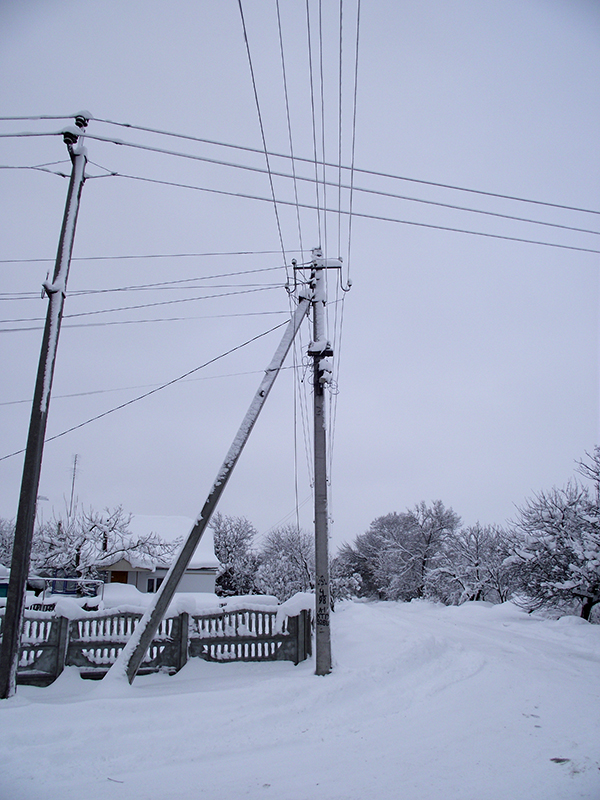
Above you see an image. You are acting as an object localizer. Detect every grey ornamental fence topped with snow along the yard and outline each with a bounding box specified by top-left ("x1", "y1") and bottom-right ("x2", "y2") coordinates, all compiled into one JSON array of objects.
[{"x1": 0, "y1": 608, "x2": 312, "y2": 685}]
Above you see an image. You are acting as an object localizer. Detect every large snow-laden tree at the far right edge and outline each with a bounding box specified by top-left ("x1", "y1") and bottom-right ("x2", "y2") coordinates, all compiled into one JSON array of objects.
[{"x1": 508, "y1": 478, "x2": 600, "y2": 619}]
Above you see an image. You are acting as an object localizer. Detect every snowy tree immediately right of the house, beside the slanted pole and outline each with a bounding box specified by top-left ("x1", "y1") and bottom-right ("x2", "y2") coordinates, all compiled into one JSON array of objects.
[{"x1": 210, "y1": 512, "x2": 258, "y2": 596}]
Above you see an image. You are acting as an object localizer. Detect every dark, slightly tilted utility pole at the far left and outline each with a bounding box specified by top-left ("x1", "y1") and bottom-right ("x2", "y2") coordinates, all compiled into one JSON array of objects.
[{"x1": 0, "y1": 114, "x2": 88, "y2": 699}]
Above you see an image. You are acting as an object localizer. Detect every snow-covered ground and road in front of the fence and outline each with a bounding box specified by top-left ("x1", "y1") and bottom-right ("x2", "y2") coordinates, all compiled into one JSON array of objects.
[{"x1": 0, "y1": 602, "x2": 600, "y2": 800}]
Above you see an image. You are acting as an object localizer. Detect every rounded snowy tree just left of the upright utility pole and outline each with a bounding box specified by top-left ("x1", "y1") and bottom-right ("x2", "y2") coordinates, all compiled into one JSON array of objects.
[{"x1": 256, "y1": 525, "x2": 315, "y2": 601}]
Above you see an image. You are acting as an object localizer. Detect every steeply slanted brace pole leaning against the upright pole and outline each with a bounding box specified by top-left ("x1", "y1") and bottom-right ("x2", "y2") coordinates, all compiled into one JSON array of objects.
[{"x1": 109, "y1": 297, "x2": 310, "y2": 683}]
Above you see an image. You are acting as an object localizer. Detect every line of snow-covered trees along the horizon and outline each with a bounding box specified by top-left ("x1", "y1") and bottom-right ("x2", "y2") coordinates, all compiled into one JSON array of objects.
[{"x1": 0, "y1": 446, "x2": 600, "y2": 620}]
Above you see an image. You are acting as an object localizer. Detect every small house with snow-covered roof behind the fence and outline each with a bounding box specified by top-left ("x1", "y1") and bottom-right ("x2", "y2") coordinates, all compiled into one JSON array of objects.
[{"x1": 97, "y1": 514, "x2": 219, "y2": 593}]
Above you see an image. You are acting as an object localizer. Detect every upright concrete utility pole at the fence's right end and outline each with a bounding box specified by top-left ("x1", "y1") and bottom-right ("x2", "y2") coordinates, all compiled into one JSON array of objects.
[{"x1": 308, "y1": 248, "x2": 341, "y2": 675}]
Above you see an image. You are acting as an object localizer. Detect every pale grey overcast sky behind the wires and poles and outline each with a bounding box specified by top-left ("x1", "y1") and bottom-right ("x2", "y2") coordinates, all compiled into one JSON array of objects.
[{"x1": 0, "y1": 0, "x2": 600, "y2": 544}]
